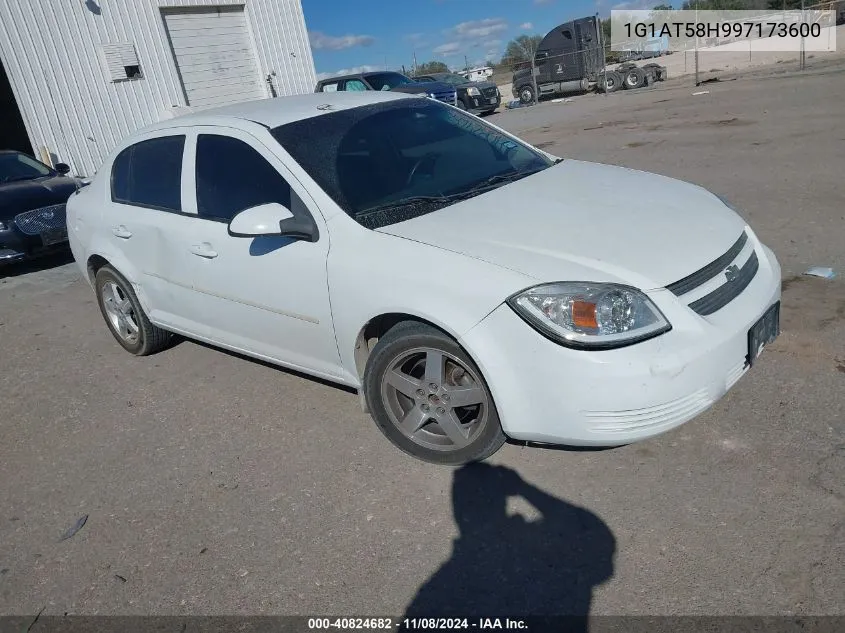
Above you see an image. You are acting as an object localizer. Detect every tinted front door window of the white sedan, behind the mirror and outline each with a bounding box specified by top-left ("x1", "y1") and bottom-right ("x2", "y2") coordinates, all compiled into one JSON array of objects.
[{"x1": 196, "y1": 134, "x2": 291, "y2": 221}]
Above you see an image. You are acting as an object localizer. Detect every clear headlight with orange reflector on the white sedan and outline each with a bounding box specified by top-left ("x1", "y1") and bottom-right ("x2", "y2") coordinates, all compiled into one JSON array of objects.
[{"x1": 508, "y1": 282, "x2": 672, "y2": 349}]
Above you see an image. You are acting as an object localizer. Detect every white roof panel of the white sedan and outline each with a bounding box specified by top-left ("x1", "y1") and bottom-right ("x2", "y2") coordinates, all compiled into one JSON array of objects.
[{"x1": 139, "y1": 90, "x2": 419, "y2": 132}]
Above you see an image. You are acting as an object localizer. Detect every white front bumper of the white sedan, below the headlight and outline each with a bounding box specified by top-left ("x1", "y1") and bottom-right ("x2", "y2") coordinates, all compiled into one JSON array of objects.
[{"x1": 461, "y1": 243, "x2": 781, "y2": 446}]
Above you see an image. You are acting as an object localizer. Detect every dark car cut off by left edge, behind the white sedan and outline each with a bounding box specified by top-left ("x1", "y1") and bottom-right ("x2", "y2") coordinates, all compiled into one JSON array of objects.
[{"x1": 0, "y1": 150, "x2": 80, "y2": 264}]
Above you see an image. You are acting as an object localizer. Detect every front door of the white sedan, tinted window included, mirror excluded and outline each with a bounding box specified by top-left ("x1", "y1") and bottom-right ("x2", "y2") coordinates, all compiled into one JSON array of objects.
[{"x1": 181, "y1": 127, "x2": 342, "y2": 377}]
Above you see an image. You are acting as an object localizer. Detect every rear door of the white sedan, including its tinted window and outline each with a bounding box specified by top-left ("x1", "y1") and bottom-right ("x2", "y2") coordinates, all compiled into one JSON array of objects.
[{"x1": 103, "y1": 129, "x2": 199, "y2": 334}]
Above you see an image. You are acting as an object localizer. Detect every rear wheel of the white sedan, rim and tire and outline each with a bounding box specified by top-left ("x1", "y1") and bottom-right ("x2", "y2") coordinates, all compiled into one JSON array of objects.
[{"x1": 94, "y1": 265, "x2": 173, "y2": 356}]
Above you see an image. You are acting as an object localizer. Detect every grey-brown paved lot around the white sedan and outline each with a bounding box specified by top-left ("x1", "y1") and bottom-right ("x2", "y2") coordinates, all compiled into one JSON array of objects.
[{"x1": 0, "y1": 61, "x2": 845, "y2": 615}]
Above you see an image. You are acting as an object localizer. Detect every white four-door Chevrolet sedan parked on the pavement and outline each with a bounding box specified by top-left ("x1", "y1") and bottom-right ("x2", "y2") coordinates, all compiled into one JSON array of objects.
[{"x1": 67, "y1": 92, "x2": 781, "y2": 464}]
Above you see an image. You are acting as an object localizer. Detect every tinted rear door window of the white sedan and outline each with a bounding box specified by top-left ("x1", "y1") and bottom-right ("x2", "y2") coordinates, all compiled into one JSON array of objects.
[{"x1": 111, "y1": 136, "x2": 185, "y2": 212}]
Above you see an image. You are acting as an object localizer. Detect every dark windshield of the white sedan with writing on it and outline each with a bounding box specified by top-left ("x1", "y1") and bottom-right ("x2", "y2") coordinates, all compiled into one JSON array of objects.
[{"x1": 273, "y1": 99, "x2": 553, "y2": 229}]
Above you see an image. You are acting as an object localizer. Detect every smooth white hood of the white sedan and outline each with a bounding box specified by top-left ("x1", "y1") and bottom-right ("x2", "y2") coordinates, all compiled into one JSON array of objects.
[{"x1": 378, "y1": 160, "x2": 745, "y2": 290}]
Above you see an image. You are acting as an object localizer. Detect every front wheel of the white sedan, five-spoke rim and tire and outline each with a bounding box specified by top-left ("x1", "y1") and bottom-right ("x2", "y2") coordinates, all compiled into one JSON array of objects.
[{"x1": 363, "y1": 321, "x2": 506, "y2": 465}]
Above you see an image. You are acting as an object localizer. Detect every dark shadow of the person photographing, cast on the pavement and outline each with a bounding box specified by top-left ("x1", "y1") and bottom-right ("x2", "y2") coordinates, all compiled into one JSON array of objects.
[{"x1": 403, "y1": 463, "x2": 616, "y2": 631}]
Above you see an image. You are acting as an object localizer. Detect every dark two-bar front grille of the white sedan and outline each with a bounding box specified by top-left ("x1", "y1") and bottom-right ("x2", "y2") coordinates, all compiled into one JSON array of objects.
[{"x1": 667, "y1": 231, "x2": 760, "y2": 316}]
